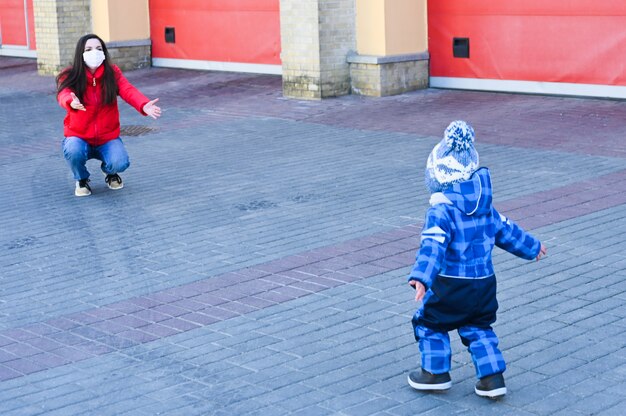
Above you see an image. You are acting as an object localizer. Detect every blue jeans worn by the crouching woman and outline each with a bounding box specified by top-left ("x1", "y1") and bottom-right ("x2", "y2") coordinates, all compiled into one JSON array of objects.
[{"x1": 63, "y1": 136, "x2": 130, "y2": 181}]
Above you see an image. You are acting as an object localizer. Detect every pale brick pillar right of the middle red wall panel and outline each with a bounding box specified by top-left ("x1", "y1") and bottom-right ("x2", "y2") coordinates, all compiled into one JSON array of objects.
[{"x1": 280, "y1": 0, "x2": 356, "y2": 99}]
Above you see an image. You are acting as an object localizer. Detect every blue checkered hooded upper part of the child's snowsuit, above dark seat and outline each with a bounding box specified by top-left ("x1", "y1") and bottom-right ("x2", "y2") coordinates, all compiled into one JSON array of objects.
[{"x1": 409, "y1": 168, "x2": 541, "y2": 288}]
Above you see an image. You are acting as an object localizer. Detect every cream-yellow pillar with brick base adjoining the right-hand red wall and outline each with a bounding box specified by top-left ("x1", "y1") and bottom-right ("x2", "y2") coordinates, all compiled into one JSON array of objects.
[{"x1": 348, "y1": 0, "x2": 429, "y2": 96}]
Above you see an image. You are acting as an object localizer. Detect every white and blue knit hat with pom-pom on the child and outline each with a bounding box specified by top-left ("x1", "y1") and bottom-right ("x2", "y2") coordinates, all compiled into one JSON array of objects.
[{"x1": 425, "y1": 120, "x2": 478, "y2": 193}]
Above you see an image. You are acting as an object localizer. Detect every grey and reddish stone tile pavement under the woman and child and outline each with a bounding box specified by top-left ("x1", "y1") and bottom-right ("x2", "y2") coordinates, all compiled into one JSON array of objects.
[{"x1": 0, "y1": 57, "x2": 626, "y2": 416}]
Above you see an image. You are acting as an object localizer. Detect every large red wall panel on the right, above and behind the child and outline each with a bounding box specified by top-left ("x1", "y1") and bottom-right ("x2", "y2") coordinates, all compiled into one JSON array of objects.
[{"x1": 428, "y1": 0, "x2": 626, "y2": 85}]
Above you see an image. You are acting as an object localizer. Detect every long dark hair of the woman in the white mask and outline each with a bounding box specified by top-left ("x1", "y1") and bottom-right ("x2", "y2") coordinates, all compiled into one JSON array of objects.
[{"x1": 56, "y1": 33, "x2": 117, "y2": 104}]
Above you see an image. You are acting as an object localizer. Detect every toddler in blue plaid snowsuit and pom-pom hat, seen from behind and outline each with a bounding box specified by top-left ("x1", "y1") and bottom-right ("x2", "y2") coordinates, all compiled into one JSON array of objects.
[{"x1": 408, "y1": 121, "x2": 546, "y2": 398}]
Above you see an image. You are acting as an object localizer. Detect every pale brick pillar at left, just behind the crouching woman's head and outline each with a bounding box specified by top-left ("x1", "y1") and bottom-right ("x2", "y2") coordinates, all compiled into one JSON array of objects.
[{"x1": 33, "y1": 0, "x2": 91, "y2": 75}]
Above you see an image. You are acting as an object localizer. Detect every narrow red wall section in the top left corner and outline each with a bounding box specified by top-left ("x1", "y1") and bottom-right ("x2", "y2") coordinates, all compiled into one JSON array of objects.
[{"x1": 0, "y1": 0, "x2": 35, "y2": 50}]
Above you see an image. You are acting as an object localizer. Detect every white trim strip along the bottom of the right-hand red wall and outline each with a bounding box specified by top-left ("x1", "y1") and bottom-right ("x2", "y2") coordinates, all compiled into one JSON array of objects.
[{"x1": 430, "y1": 77, "x2": 626, "y2": 98}]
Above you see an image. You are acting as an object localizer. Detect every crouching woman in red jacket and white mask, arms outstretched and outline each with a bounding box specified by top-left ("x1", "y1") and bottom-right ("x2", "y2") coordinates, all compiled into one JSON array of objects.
[{"x1": 56, "y1": 34, "x2": 161, "y2": 196}]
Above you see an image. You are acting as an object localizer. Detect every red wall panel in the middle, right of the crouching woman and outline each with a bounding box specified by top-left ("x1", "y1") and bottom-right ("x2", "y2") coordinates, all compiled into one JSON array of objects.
[{"x1": 150, "y1": 0, "x2": 280, "y2": 65}]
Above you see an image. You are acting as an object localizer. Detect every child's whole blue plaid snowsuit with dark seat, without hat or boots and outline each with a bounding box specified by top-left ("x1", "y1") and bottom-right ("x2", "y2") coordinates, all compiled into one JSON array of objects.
[{"x1": 409, "y1": 168, "x2": 541, "y2": 378}]
